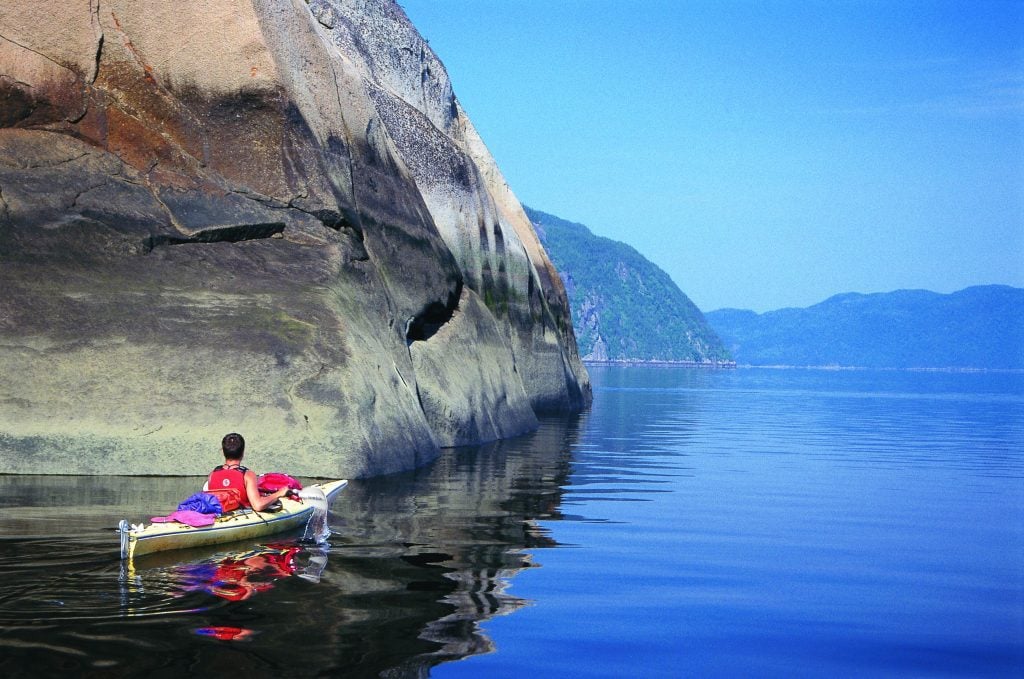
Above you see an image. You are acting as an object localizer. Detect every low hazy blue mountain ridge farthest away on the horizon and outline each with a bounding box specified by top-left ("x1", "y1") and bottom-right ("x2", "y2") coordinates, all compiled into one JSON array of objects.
[{"x1": 706, "y1": 286, "x2": 1024, "y2": 370}]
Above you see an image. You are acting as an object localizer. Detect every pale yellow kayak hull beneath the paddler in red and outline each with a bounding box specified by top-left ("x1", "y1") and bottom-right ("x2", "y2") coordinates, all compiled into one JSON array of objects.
[{"x1": 118, "y1": 480, "x2": 348, "y2": 560}]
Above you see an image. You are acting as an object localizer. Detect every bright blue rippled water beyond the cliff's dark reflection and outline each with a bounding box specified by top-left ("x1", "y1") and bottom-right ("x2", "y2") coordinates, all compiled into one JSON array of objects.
[{"x1": 435, "y1": 368, "x2": 1024, "y2": 677}]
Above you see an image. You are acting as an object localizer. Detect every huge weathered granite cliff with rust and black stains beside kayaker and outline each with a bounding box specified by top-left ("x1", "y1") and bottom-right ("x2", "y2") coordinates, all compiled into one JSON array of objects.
[{"x1": 0, "y1": 0, "x2": 590, "y2": 476}]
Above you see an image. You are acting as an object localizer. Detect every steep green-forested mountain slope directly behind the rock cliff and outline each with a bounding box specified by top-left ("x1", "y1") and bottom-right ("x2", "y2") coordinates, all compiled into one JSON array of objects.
[{"x1": 526, "y1": 208, "x2": 730, "y2": 364}]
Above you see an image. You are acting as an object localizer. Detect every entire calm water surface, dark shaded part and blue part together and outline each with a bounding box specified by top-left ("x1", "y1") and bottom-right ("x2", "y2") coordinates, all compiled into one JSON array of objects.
[{"x1": 0, "y1": 368, "x2": 1024, "y2": 677}]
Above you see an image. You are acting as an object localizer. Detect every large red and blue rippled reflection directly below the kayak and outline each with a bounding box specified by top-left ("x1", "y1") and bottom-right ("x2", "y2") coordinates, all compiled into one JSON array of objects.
[{"x1": 174, "y1": 545, "x2": 327, "y2": 601}]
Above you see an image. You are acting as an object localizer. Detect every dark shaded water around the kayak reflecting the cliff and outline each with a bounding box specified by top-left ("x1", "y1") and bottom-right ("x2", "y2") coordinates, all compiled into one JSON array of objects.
[{"x1": 0, "y1": 418, "x2": 581, "y2": 677}]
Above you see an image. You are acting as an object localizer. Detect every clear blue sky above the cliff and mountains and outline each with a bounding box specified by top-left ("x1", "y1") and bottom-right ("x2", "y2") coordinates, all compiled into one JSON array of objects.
[{"x1": 400, "y1": 0, "x2": 1024, "y2": 311}]
